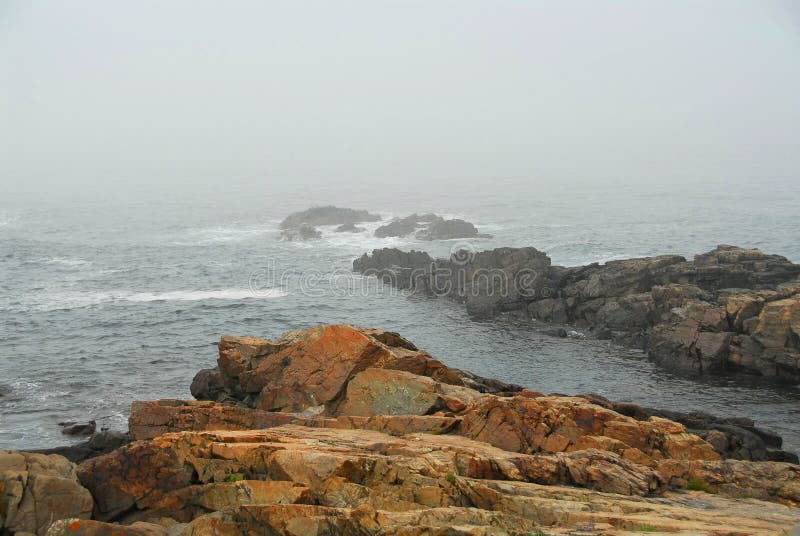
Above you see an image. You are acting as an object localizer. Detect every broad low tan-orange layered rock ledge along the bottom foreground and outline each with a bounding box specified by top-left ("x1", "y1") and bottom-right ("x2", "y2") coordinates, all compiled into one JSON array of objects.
[{"x1": 75, "y1": 425, "x2": 800, "y2": 534}]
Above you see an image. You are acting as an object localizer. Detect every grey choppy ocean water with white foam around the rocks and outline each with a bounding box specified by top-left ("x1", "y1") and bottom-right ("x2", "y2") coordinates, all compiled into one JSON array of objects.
[{"x1": 0, "y1": 179, "x2": 800, "y2": 451}]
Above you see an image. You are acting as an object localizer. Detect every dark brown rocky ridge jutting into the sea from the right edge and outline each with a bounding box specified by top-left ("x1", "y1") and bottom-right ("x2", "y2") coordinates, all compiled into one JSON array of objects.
[{"x1": 353, "y1": 246, "x2": 800, "y2": 383}]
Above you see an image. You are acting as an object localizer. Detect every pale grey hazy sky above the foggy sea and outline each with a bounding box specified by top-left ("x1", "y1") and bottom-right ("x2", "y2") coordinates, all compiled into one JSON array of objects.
[{"x1": 0, "y1": 0, "x2": 800, "y2": 195}]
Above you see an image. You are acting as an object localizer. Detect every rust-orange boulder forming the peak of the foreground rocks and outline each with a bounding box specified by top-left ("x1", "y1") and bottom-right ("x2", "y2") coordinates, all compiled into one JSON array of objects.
[{"x1": 191, "y1": 325, "x2": 521, "y2": 412}]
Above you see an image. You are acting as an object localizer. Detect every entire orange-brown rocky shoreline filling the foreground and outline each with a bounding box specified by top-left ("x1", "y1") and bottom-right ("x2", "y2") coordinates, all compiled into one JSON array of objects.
[{"x1": 0, "y1": 325, "x2": 800, "y2": 535}]
